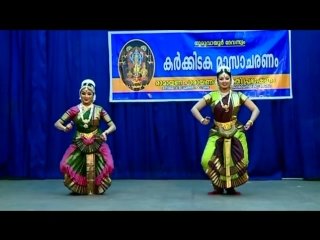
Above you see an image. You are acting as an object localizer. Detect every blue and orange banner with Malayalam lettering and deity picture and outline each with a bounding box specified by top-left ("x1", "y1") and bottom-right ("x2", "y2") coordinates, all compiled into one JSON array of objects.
[{"x1": 108, "y1": 30, "x2": 292, "y2": 102}]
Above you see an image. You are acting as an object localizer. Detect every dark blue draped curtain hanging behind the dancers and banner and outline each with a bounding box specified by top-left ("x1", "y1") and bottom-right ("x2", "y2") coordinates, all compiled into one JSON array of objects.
[{"x1": 0, "y1": 30, "x2": 320, "y2": 180}]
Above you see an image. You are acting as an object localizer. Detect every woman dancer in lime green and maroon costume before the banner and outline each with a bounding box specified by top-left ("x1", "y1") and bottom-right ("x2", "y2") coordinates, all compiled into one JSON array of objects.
[{"x1": 191, "y1": 66, "x2": 260, "y2": 195}]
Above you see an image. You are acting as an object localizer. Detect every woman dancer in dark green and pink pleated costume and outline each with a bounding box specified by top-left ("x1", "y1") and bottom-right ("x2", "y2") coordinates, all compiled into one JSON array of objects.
[{"x1": 55, "y1": 79, "x2": 116, "y2": 195}]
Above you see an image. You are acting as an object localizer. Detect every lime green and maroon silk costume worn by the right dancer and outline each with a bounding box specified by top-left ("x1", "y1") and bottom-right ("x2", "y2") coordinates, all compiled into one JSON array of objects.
[{"x1": 201, "y1": 91, "x2": 249, "y2": 189}]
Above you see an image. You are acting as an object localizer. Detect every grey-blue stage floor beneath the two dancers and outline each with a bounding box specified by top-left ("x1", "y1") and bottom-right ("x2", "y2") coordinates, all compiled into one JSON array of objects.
[{"x1": 0, "y1": 180, "x2": 320, "y2": 211}]
